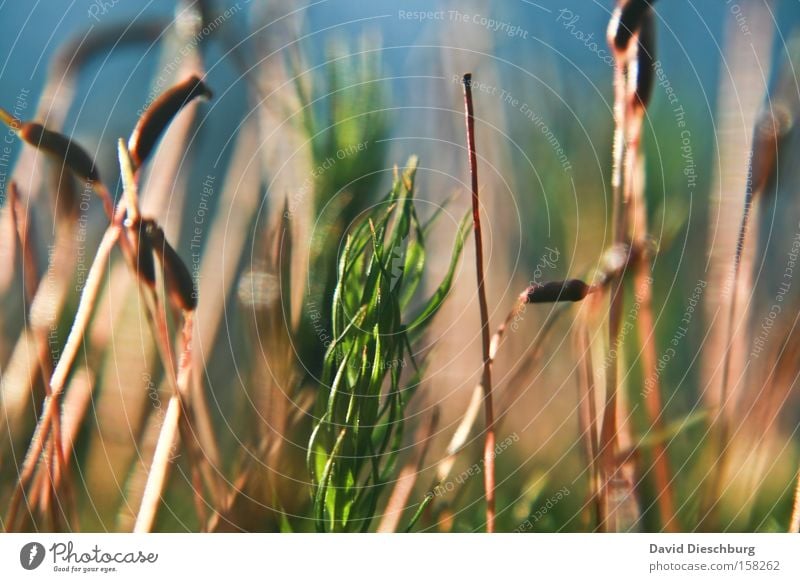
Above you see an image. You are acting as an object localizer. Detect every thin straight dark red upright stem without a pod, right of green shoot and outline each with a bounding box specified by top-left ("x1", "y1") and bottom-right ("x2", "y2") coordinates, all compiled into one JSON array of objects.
[{"x1": 463, "y1": 73, "x2": 495, "y2": 533}]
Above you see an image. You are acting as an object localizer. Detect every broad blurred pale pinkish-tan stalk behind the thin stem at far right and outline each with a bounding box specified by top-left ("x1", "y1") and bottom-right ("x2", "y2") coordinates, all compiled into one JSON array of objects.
[{"x1": 697, "y1": 5, "x2": 780, "y2": 530}]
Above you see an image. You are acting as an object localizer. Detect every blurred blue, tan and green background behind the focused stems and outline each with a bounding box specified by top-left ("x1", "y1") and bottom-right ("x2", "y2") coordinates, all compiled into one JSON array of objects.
[{"x1": 0, "y1": 0, "x2": 800, "y2": 531}]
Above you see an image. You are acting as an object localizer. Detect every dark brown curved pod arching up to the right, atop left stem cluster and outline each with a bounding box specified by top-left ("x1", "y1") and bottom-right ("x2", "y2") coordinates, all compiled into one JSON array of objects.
[{"x1": 128, "y1": 75, "x2": 212, "y2": 168}]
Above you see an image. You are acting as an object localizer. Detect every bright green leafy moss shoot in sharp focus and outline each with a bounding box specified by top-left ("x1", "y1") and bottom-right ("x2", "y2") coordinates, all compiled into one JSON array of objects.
[{"x1": 308, "y1": 158, "x2": 468, "y2": 531}]
